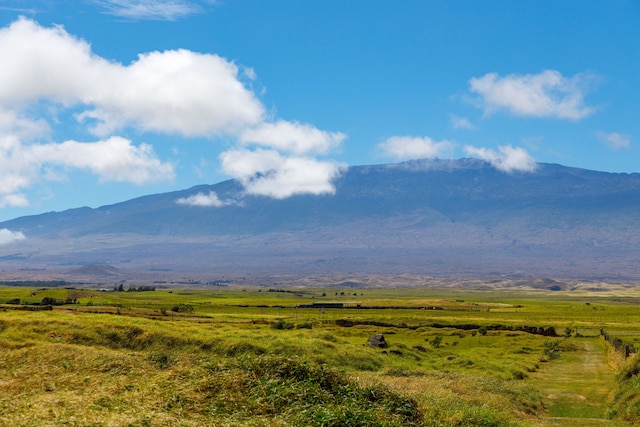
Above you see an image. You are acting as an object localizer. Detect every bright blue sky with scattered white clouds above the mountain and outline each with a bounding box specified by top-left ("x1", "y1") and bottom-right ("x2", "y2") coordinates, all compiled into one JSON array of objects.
[{"x1": 0, "y1": 0, "x2": 640, "y2": 229}]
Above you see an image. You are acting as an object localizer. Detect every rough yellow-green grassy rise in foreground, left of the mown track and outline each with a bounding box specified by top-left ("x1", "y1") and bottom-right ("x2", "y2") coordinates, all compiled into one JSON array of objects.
[{"x1": 0, "y1": 311, "x2": 541, "y2": 426}]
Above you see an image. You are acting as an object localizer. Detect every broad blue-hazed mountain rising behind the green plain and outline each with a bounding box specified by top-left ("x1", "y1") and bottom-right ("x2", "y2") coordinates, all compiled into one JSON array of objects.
[{"x1": 0, "y1": 159, "x2": 640, "y2": 281}]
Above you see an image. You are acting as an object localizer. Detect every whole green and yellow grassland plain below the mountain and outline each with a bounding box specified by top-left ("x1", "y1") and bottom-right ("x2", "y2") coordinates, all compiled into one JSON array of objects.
[{"x1": 0, "y1": 287, "x2": 640, "y2": 426}]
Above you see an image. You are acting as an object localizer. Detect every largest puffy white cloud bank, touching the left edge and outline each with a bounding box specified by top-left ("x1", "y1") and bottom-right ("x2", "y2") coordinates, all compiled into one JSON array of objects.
[{"x1": 0, "y1": 18, "x2": 255, "y2": 207}]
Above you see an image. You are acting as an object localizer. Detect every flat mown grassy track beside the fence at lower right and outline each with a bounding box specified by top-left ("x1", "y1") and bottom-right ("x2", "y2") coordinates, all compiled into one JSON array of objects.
[{"x1": 531, "y1": 338, "x2": 628, "y2": 427}]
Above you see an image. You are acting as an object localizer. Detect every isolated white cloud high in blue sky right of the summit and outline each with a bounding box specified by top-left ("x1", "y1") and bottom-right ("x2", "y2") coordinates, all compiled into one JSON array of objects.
[{"x1": 469, "y1": 70, "x2": 594, "y2": 120}]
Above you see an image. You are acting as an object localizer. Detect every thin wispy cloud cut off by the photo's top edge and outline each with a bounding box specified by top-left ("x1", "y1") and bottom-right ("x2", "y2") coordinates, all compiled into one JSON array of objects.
[{"x1": 94, "y1": 0, "x2": 213, "y2": 21}]
